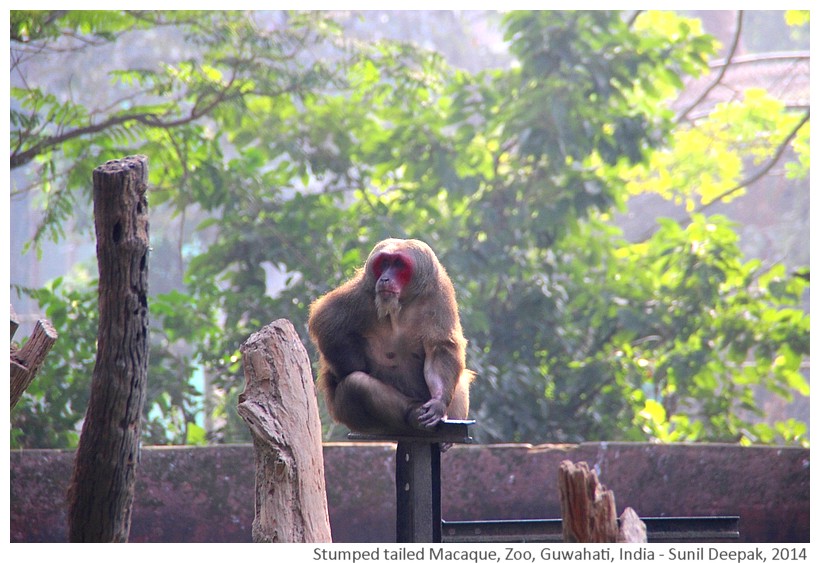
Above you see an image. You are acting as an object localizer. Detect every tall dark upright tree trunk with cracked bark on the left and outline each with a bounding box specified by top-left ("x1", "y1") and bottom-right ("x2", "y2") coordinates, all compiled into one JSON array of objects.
[{"x1": 68, "y1": 156, "x2": 149, "y2": 542}]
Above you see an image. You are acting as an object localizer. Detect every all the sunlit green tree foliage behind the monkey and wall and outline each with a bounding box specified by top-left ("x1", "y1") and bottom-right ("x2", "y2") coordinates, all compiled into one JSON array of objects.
[{"x1": 11, "y1": 11, "x2": 809, "y2": 446}]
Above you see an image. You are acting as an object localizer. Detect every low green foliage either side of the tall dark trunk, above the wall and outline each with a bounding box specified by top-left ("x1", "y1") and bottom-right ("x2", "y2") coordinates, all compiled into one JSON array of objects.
[{"x1": 11, "y1": 278, "x2": 214, "y2": 448}]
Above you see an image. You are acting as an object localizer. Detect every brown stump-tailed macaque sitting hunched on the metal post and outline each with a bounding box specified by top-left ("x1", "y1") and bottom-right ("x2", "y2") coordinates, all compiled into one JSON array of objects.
[{"x1": 308, "y1": 239, "x2": 472, "y2": 434}]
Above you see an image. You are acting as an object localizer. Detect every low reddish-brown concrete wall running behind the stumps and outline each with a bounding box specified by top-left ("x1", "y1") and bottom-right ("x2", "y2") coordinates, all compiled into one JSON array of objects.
[{"x1": 10, "y1": 443, "x2": 810, "y2": 542}]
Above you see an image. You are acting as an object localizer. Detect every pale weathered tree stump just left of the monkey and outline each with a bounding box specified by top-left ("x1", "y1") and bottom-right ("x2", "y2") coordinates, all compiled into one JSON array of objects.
[{"x1": 237, "y1": 319, "x2": 331, "y2": 543}]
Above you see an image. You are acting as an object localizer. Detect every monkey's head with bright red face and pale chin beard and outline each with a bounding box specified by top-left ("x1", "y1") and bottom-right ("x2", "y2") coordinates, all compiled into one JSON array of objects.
[{"x1": 365, "y1": 239, "x2": 440, "y2": 317}]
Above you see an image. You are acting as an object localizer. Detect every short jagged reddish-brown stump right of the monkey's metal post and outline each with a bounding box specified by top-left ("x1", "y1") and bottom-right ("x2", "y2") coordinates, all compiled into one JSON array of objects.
[{"x1": 558, "y1": 460, "x2": 646, "y2": 543}]
